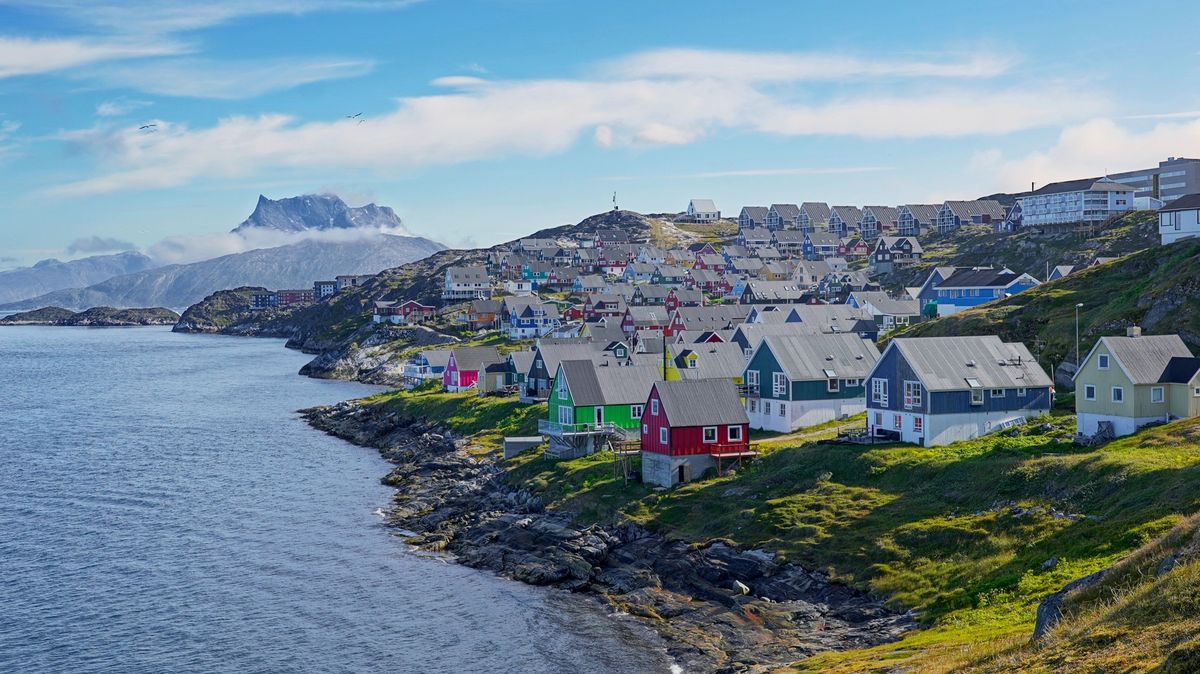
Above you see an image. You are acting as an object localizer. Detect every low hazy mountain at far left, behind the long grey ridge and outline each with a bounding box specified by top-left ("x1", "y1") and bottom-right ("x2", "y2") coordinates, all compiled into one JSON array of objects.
[{"x1": 0, "y1": 251, "x2": 157, "y2": 303}]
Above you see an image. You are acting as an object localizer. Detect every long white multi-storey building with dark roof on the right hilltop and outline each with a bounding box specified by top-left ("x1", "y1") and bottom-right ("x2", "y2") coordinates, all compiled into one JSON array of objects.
[{"x1": 1020, "y1": 177, "x2": 1134, "y2": 227}]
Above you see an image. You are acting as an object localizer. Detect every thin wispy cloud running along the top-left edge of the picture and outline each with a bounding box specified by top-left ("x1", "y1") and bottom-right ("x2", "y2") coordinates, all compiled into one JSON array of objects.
[{"x1": 7, "y1": 0, "x2": 420, "y2": 35}]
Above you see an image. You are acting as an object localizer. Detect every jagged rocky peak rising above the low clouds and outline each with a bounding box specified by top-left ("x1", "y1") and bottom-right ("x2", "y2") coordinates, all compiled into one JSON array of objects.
[{"x1": 233, "y1": 194, "x2": 408, "y2": 234}]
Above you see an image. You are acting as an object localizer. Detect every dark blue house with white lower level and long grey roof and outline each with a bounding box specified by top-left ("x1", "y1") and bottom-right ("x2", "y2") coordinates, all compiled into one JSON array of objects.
[{"x1": 865, "y1": 335, "x2": 1054, "y2": 447}]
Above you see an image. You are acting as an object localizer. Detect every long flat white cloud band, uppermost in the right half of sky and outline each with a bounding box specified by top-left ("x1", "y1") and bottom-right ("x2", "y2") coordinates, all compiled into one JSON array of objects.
[{"x1": 602, "y1": 49, "x2": 1013, "y2": 82}]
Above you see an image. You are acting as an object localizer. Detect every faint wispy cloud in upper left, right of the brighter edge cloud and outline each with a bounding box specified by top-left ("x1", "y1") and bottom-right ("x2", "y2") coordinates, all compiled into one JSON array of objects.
[{"x1": 80, "y1": 58, "x2": 374, "y2": 100}]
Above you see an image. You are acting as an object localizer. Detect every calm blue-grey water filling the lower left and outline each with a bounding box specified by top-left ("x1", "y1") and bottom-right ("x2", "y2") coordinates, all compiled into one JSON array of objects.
[{"x1": 0, "y1": 327, "x2": 667, "y2": 673}]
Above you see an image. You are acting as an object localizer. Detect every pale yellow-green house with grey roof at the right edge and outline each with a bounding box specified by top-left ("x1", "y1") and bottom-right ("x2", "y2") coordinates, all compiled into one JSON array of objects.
[{"x1": 1075, "y1": 327, "x2": 1200, "y2": 437}]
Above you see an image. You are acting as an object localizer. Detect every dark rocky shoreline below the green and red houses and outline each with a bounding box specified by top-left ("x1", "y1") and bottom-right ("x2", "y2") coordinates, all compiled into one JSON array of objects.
[{"x1": 302, "y1": 401, "x2": 916, "y2": 672}]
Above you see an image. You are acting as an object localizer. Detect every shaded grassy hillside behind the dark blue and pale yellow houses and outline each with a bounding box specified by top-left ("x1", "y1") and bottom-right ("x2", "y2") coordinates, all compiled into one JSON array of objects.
[{"x1": 904, "y1": 233, "x2": 1200, "y2": 365}]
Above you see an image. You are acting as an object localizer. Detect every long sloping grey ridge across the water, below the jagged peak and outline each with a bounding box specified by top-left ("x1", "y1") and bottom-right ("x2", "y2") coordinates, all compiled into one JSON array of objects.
[{"x1": 0, "y1": 231, "x2": 444, "y2": 311}]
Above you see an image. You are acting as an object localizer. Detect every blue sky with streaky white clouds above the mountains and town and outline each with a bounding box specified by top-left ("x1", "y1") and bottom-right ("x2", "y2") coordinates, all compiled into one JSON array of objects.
[{"x1": 0, "y1": 0, "x2": 1200, "y2": 269}]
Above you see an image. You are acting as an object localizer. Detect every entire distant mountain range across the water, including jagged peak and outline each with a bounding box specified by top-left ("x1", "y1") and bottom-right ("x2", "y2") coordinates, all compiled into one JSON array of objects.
[{"x1": 0, "y1": 194, "x2": 445, "y2": 311}]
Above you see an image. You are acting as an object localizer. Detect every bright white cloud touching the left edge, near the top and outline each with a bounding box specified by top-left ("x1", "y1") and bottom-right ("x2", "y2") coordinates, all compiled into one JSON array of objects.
[{"x1": 0, "y1": 36, "x2": 184, "y2": 78}]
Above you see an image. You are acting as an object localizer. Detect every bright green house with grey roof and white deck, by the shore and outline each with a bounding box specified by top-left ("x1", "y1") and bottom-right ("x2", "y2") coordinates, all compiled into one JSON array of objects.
[{"x1": 539, "y1": 360, "x2": 661, "y2": 458}]
